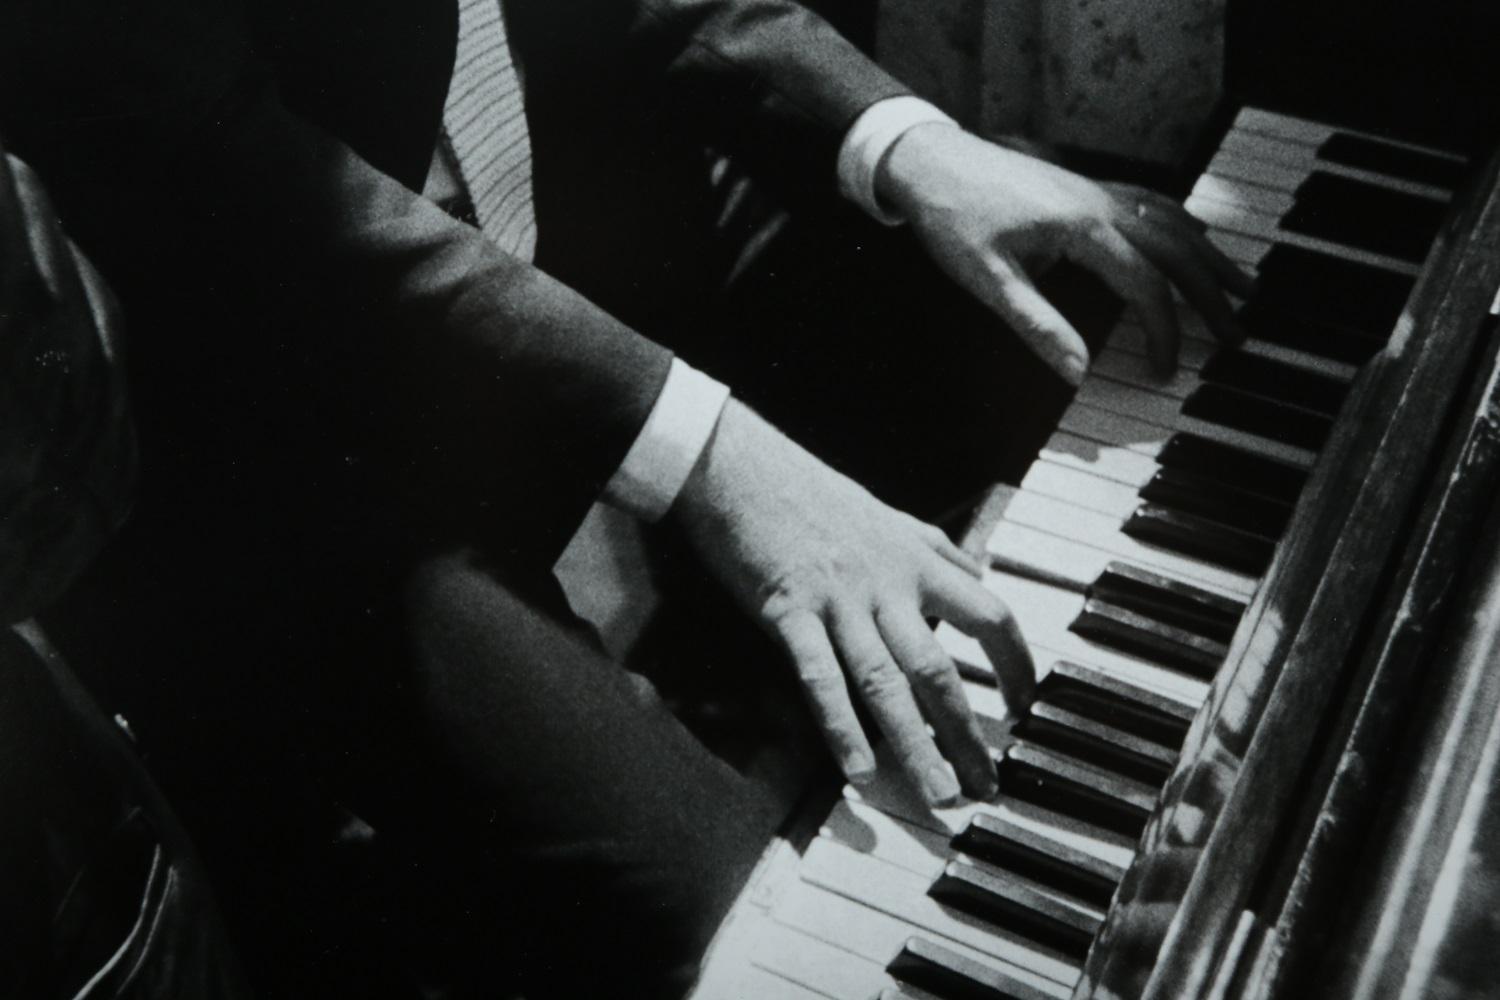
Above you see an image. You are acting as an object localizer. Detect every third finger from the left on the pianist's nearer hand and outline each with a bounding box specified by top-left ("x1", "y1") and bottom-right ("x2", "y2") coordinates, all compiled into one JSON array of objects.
[{"x1": 876, "y1": 601, "x2": 998, "y2": 799}]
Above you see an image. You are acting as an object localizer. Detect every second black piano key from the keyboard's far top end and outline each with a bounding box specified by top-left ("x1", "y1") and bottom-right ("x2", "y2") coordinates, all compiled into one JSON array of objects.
[{"x1": 1281, "y1": 171, "x2": 1448, "y2": 264}]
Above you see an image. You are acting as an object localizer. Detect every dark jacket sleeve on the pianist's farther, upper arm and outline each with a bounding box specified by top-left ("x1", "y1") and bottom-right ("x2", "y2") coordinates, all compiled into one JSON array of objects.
[{"x1": 504, "y1": 0, "x2": 911, "y2": 196}]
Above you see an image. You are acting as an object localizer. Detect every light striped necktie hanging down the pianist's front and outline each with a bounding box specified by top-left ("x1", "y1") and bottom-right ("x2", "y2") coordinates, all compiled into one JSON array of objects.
[{"x1": 443, "y1": 0, "x2": 537, "y2": 259}]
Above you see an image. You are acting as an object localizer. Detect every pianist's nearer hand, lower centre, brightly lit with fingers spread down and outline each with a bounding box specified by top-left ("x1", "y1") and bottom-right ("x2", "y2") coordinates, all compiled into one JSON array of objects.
[{"x1": 672, "y1": 399, "x2": 1035, "y2": 805}]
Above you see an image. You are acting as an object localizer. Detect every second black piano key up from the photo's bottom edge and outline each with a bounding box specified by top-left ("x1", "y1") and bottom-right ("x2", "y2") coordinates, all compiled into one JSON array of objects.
[{"x1": 929, "y1": 861, "x2": 1104, "y2": 961}]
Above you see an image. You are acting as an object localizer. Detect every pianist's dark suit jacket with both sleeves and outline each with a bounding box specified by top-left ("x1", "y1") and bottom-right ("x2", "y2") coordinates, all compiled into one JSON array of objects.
[{"x1": 0, "y1": 0, "x2": 902, "y2": 563}]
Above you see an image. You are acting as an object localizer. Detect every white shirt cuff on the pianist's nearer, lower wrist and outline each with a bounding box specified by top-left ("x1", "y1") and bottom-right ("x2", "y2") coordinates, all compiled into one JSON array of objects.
[{"x1": 605, "y1": 358, "x2": 729, "y2": 522}]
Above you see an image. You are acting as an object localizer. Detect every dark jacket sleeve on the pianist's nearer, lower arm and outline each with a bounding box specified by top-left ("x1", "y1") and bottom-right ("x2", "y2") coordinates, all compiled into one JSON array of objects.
[{"x1": 0, "y1": 0, "x2": 671, "y2": 563}]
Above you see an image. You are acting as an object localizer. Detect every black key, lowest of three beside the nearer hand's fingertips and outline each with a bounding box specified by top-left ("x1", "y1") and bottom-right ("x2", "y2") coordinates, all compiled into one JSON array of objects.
[{"x1": 1001, "y1": 741, "x2": 1157, "y2": 837}]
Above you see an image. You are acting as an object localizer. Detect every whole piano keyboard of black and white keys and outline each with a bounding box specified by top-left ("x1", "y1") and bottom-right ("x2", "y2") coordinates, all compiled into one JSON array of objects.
[{"x1": 695, "y1": 108, "x2": 1464, "y2": 1000}]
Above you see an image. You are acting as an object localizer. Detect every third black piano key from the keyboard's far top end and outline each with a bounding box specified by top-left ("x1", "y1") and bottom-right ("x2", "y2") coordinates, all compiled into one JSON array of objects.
[{"x1": 1248, "y1": 243, "x2": 1413, "y2": 342}]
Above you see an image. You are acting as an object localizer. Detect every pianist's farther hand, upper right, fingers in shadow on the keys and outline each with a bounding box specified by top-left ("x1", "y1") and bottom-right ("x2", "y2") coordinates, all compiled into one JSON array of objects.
[{"x1": 876, "y1": 123, "x2": 1251, "y2": 385}]
